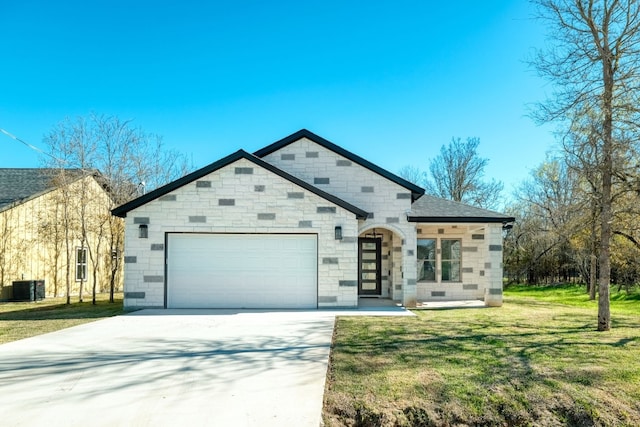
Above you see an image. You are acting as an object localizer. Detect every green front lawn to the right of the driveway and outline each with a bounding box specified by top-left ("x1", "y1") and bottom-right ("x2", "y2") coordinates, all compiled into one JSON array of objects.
[{"x1": 324, "y1": 288, "x2": 640, "y2": 426}]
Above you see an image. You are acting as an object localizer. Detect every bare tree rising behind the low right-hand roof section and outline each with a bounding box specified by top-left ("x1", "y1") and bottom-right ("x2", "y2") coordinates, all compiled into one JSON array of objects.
[{"x1": 425, "y1": 138, "x2": 504, "y2": 209}]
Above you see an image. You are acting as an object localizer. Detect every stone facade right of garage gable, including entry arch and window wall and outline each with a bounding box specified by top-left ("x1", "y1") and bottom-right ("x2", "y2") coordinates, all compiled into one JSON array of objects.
[{"x1": 263, "y1": 138, "x2": 502, "y2": 307}]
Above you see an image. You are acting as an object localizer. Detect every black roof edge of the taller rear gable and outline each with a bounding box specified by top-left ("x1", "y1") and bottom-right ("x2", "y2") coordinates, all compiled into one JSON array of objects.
[{"x1": 253, "y1": 129, "x2": 425, "y2": 201}]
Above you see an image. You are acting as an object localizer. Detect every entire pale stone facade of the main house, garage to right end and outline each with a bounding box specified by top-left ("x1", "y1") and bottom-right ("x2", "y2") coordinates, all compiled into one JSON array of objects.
[{"x1": 119, "y1": 132, "x2": 510, "y2": 308}]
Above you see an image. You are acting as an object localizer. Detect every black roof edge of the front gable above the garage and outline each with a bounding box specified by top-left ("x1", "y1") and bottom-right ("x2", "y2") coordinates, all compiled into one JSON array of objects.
[{"x1": 111, "y1": 150, "x2": 369, "y2": 219}]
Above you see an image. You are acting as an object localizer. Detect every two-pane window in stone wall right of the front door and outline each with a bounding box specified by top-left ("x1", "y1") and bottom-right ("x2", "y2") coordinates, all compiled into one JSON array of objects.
[{"x1": 417, "y1": 239, "x2": 462, "y2": 282}]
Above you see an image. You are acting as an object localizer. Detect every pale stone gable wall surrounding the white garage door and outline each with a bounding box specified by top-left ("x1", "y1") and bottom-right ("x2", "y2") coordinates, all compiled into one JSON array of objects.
[{"x1": 125, "y1": 159, "x2": 358, "y2": 307}]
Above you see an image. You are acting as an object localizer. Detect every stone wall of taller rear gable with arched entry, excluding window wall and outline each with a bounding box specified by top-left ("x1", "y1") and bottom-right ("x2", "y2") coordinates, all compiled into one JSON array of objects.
[{"x1": 263, "y1": 138, "x2": 417, "y2": 307}]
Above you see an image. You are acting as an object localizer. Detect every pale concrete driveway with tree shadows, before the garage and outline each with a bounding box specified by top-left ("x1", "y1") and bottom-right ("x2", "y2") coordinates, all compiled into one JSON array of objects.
[{"x1": 0, "y1": 310, "x2": 336, "y2": 427}]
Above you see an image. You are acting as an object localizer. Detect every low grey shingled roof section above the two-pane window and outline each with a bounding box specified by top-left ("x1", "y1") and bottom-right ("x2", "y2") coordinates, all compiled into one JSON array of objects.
[{"x1": 407, "y1": 194, "x2": 515, "y2": 224}]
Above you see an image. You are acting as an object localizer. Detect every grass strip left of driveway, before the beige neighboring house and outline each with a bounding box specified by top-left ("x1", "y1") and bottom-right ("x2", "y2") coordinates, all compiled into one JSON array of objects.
[{"x1": 0, "y1": 293, "x2": 124, "y2": 344}]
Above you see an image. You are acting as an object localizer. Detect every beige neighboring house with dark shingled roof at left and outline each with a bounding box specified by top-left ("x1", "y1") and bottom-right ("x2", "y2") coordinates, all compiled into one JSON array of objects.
[{"x1": 0, "y1": 168, "x2": 122, "y2": 299}]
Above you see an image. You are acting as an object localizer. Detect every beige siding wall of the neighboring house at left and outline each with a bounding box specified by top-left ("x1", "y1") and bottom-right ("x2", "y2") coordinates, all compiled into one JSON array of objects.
[{"x1": 0, "y1": 177, "x2": 121, "y2": 297}]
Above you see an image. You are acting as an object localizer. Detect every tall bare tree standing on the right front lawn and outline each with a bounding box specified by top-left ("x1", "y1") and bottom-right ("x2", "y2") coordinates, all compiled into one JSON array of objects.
[{"x1": 533, "y1": 0, "x2": 640, "y2": 331}]
